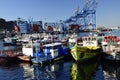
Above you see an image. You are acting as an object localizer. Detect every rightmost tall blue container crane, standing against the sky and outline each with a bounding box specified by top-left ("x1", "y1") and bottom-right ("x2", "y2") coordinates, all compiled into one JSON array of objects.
[{"x1": 83, "y1": 0, "x2": 98, "y2": 30}]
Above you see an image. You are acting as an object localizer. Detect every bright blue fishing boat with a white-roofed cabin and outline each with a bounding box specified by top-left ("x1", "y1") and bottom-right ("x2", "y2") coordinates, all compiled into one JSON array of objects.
[{"x1": 32, "y1": 42, "x2": 69, "y2": 64}]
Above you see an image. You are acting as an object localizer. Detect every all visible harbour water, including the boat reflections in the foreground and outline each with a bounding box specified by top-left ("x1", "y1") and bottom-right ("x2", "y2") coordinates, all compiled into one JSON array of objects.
[{"x1": 0, "y1": 31, "x2": 120, "y2": 80}]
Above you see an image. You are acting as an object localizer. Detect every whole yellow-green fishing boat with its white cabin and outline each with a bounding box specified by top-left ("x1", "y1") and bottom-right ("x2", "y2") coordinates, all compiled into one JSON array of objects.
[{"x1": 71, "y1": 35, "x2": 101, "y2": 62}]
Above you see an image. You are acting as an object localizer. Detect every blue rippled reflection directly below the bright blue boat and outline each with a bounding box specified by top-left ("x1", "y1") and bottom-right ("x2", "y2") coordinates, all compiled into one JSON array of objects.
[{"x1": 33, "y1": 65, "x2": 57, "y2": 80}]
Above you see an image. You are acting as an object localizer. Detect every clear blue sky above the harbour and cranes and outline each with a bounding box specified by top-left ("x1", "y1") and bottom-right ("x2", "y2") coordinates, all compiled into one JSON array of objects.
[{"x1": 0, "y1": 0, "x2": 120, "y2": 27}]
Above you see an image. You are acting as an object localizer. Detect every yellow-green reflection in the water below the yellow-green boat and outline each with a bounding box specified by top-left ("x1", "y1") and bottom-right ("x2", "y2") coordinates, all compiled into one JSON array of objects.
[{"x1": 71, "y1": 62, "x2": 98, "y2": 80}]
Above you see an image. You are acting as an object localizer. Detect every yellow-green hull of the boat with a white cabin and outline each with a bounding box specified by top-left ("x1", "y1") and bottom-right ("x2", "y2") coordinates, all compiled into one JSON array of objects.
[{"x1": 71, "y1": 46, "x2": 100, "y2": 62}]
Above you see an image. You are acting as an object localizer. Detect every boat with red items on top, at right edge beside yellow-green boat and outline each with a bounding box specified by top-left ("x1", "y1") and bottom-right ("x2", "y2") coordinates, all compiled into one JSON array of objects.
[{"x1": 102, "y1": 35, "x2": 120, "y2": 62}]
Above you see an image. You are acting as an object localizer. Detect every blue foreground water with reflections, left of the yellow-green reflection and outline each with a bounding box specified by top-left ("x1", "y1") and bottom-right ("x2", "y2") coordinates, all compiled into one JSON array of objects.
[{"x1": 0, "y1": 61, "x2": 71, "y2": 80}]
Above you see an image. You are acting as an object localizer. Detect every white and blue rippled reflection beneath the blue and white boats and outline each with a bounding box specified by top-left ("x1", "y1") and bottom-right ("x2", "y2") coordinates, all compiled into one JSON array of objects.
[{"x1": 20, "y1": 63, "x2": 64, "y2": 80}]
